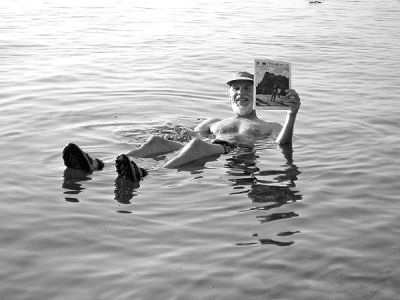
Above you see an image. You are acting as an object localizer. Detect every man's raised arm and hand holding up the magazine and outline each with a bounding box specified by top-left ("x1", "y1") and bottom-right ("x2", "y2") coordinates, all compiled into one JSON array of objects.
[{"x1": 276, "y1": 89, "x2": 301, "y2": 145}]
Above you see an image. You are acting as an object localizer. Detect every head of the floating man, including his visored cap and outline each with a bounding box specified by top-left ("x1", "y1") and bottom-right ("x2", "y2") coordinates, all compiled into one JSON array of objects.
[{"x1": 227, "y1": 71, "x2": 254, "y2": 116}]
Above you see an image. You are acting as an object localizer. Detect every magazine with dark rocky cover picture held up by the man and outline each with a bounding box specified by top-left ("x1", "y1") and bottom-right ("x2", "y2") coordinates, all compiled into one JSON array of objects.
[{"x1": 254, "y1": 59, "x2": 291, "y2": 110}]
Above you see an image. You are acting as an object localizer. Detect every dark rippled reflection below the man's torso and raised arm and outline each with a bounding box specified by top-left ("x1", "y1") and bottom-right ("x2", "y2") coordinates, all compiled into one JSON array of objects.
[{"x1": 226, "y1": 146, "x2": 302, "y2": 246}]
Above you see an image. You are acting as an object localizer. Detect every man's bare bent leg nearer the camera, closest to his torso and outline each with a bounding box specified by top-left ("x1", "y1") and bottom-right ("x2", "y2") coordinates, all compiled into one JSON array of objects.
[{"x1": 164, "y1": 138, "x2": 225, "y2": 168}]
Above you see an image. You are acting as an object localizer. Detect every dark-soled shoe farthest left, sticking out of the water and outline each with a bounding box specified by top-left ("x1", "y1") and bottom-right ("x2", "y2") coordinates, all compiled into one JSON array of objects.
[{"x1": 63, "y1": 143, "x2": 104, "y2": 172}]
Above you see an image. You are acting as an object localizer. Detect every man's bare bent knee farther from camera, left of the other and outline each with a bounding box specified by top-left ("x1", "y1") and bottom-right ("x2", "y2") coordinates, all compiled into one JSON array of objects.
[{"x1": 126, "y1": 136, "x2": 183, "y2": 157}]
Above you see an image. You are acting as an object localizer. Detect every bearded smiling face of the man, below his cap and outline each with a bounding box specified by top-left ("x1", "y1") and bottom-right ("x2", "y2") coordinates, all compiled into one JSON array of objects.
[{"x1": 229, "y1": 81, "x2": 253, "y2": 116}]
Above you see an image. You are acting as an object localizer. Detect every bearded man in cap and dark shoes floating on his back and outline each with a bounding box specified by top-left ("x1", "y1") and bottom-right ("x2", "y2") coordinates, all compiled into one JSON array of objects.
[{"x1": 63, "y1": 72, "x2": 300, "y2": 182}]
